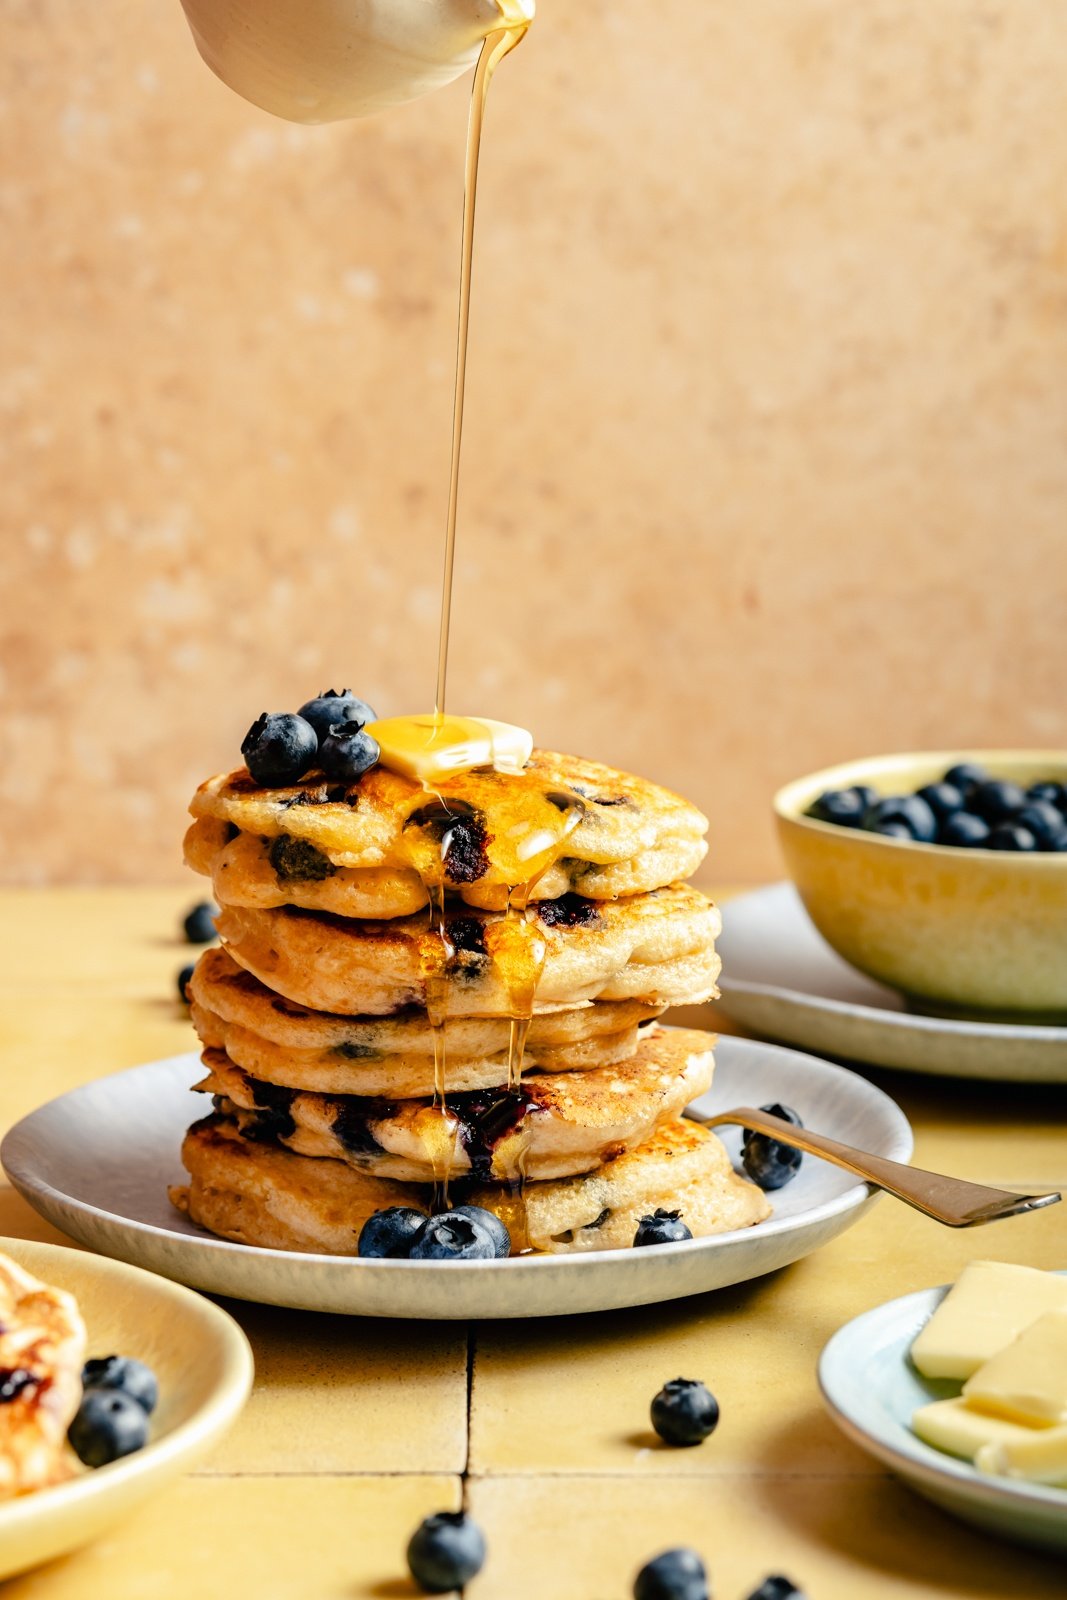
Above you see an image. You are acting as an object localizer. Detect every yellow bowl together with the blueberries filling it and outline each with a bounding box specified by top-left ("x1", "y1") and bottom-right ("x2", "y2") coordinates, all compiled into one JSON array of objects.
[{"x1": 774, "y1": 750, "x2": 1067, "y2": 1022}]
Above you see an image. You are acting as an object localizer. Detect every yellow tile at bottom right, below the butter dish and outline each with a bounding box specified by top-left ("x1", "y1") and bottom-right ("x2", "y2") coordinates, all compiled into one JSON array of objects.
[{"x1": 466, "y1": 1474, "x2": 1064, "y2": 1600}]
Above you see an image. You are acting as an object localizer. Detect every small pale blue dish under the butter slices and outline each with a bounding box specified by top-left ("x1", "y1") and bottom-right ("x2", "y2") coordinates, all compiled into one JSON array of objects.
[{"x1": 819, "y1": 1285, "x2": 1067, "y2": 1550}]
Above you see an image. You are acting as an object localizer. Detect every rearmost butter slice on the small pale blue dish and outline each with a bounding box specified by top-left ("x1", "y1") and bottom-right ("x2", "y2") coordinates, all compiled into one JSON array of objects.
[{"x1": 912, "y1": 1261, "x2": 1067, "y2": 1379}]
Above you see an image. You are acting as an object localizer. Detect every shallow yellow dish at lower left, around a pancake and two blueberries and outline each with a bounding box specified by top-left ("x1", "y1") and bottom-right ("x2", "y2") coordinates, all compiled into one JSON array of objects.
[{"x1": 0, "y1": 1238, "x2": 253, "y2": 1578}]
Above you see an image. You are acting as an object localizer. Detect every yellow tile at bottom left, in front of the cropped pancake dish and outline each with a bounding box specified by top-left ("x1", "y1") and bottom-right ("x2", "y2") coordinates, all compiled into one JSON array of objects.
[{"x1": 2, "y1": 1475, "x2": 461, "y2": 1600}]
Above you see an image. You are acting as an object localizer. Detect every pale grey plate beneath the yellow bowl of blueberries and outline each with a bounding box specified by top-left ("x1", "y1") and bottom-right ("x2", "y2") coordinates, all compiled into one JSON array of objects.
[{"x1": 718, "y1": 883, "x2": 1067, "y2": 1083}]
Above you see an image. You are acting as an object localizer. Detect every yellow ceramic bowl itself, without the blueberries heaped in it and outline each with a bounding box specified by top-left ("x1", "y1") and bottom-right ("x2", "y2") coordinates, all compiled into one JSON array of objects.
[{"x1": 774, "y1": 750, "x2": 1067, "y2": 1014}]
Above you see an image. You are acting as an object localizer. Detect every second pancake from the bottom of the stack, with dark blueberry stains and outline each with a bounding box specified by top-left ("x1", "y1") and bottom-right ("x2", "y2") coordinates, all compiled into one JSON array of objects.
[{"x1": 197, "y1": 1024, "x2": 715, "y2": 1182}]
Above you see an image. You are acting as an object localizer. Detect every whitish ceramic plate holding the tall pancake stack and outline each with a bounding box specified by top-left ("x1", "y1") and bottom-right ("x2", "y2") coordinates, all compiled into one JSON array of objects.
[{"x1": 0, "y1": 1038, "x2": 912, "y2": 1318}]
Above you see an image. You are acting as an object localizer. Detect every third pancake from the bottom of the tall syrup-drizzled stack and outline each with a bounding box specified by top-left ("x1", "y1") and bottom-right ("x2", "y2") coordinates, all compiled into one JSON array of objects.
[{"x1": 189, "y1": 949, "x2": 662, "y2": 1099}]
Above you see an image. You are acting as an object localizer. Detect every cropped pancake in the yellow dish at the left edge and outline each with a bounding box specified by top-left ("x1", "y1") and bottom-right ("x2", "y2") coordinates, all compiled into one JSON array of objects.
[{"x1": 0, "y1": 1256, "x2": 85, "y2": 1501}]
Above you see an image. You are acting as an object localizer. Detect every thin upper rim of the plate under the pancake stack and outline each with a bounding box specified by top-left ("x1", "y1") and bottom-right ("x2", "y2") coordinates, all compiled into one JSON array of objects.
[{"x1": 0, "y1": 1030, "x2": 915, "y2": 1273}]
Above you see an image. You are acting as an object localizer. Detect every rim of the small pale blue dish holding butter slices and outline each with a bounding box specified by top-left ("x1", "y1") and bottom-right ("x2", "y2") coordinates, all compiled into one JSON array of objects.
[{"x1": 816, "y1": 1283, "x2": 1067, "y2": 1514}]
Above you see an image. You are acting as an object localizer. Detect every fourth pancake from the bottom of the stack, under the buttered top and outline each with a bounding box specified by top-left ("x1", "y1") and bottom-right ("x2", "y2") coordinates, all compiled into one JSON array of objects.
[{"x1": 218, "y1": 885, "x2": 721, "y2": 1018}]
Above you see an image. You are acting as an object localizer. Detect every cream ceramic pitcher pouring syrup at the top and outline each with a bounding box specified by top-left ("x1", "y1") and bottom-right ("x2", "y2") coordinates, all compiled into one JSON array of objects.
[{"x1": 181, "y1": 0, "x2": 534, "y2": 122}]
